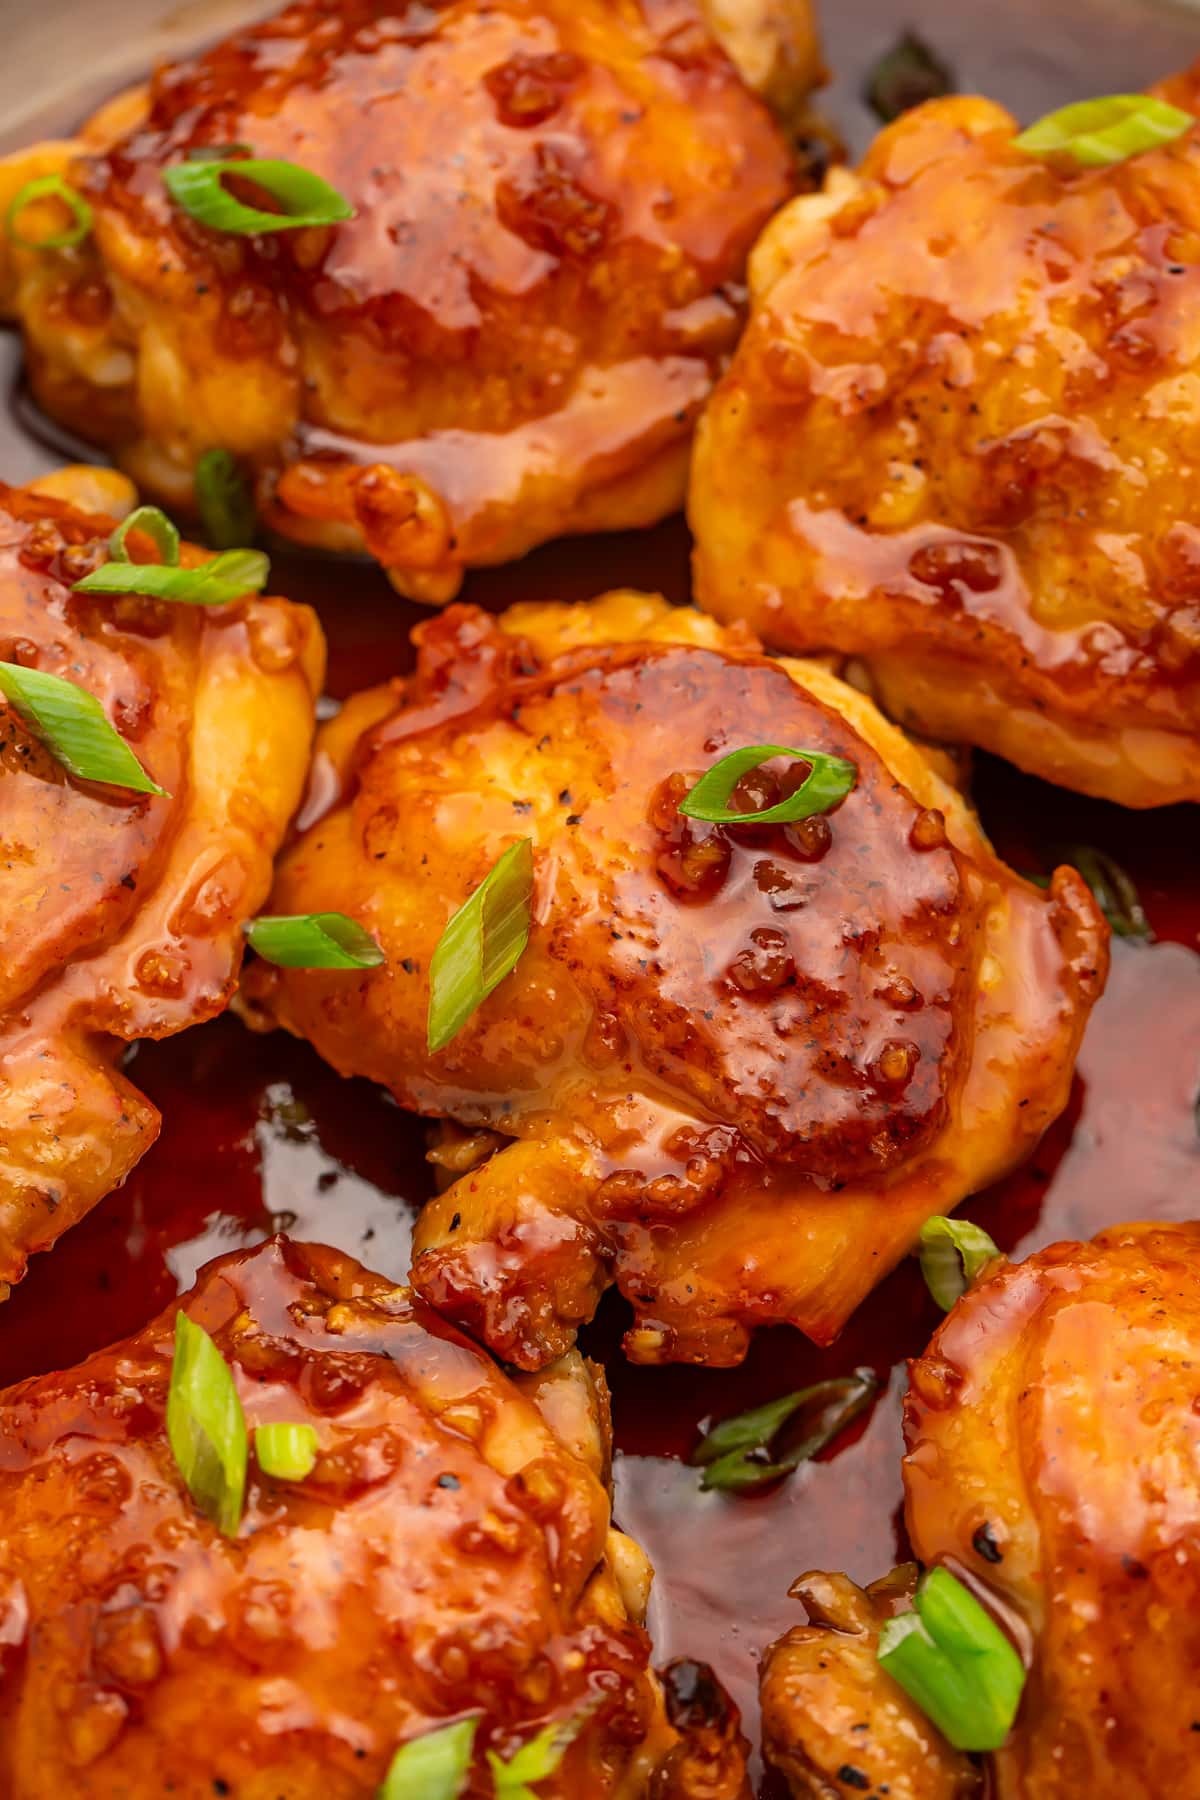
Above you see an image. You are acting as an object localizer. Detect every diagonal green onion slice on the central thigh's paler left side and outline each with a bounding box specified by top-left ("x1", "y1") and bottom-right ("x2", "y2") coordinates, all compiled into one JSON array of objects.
[{"x1": 426, "y1": 837, "x2": 533, "y2": 1051}]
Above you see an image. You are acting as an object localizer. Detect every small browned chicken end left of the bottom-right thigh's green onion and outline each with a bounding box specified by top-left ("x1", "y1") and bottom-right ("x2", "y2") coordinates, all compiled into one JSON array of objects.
[{"x1": 759, "y1": 1564, "x2": 981, "y2": 1800}]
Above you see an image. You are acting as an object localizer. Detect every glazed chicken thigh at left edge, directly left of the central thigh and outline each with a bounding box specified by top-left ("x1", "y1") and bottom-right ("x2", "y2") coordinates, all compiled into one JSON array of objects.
[{"x1": 0, "y1": 470, "x2": 324, "y2": 1294}]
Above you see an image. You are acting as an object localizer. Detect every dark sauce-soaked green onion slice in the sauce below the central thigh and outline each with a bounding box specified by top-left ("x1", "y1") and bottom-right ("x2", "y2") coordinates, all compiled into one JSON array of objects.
[{"x1": 689, "y1": 1368, "x2": 880, "y2": 1492}]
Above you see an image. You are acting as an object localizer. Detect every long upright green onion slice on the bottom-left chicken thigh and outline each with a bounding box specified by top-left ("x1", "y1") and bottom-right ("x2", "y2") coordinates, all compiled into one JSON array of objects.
[{"x1": 167, "y1": 1312, "x2": 248, "y2": 1537}]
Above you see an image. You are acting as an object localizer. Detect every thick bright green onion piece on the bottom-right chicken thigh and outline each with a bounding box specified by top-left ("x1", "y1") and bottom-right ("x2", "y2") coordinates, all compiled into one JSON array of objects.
[{"x1": 878, "y1": 1570, "x2": 1025, "y2": 1750}]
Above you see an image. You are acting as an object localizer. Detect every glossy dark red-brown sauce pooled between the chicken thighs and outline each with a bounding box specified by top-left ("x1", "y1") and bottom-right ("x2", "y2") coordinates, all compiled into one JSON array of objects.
[{"x1": 0, "y1": 0, "x2": 1200, "y2": 1796}]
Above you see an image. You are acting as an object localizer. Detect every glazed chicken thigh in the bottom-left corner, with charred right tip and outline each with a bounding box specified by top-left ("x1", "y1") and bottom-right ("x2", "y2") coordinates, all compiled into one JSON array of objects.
[{"x1": 0, "y1": 1238, "x2": 743, "y2": 1800}]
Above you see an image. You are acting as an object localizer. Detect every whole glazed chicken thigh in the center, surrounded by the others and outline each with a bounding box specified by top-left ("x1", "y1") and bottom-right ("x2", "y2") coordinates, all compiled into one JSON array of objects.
[{"x1": 243, "y1": 592, "x2": 1106, "y2": 1368}]
